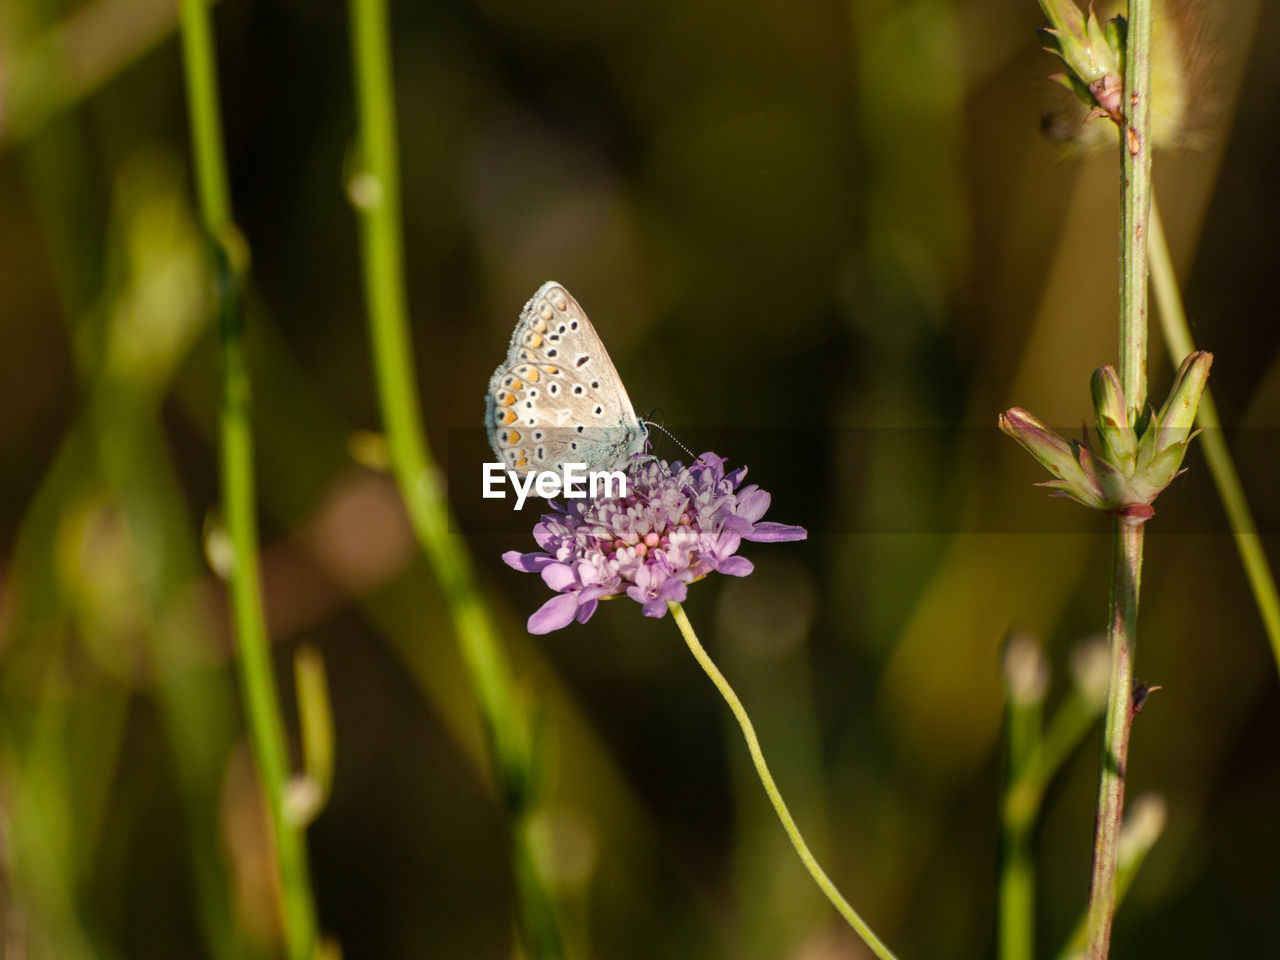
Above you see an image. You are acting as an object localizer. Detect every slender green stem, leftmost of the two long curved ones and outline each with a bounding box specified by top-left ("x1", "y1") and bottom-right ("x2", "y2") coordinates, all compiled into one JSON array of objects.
[{"x1": 182, "y1": 0, "x2": 316, "y2": 960}]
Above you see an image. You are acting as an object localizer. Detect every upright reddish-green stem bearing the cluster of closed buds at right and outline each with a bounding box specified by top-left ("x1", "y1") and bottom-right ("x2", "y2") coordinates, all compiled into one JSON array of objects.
[{"x1": 1088, "y1": 0, "x2": 1152, "y2": 960}]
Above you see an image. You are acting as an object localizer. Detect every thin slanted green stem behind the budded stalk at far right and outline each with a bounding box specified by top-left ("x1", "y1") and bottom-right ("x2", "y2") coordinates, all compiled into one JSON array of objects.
[{"x1": 1147, "y1": 193, "x2": 1280, "y2": 671}]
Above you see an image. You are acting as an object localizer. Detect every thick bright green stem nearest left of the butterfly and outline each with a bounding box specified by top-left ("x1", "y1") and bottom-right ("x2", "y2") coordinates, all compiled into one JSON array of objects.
[{"x1": 349, "y1": 0, "x2": 564, "y2": 960}]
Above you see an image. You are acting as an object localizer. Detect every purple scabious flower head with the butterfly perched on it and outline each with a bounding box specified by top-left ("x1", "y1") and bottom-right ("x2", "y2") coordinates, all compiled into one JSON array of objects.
[{"x1": 502, "y1": 453, "x2": 808, "y2": 634}]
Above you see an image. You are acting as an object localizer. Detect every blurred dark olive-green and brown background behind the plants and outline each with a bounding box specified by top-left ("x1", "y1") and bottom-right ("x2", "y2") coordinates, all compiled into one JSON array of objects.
[{"x1": 0, "y1": 0, "x2": 1280, "y2": 960}]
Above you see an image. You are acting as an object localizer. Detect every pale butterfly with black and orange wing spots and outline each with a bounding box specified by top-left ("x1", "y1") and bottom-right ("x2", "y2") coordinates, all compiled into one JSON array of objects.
[{"x1": 485, "y1": 282, "x2": 649, "y2": 474}]
